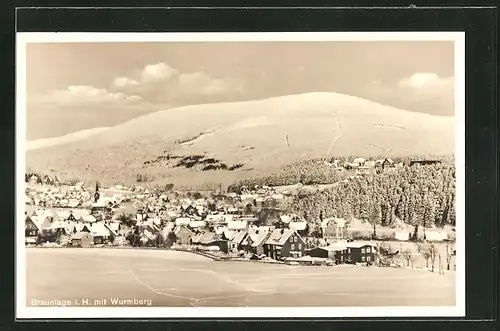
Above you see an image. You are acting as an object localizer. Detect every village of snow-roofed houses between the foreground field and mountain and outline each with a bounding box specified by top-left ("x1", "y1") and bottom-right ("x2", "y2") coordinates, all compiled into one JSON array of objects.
[{"x1": 25, "y1": 159, "x2": 450, "y2": 268}]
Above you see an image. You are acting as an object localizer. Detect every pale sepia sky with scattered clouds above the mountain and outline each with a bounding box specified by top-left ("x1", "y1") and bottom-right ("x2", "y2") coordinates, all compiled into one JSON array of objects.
[{"x1": 26, "y1": 41, "x2": 454, "y2": 140}]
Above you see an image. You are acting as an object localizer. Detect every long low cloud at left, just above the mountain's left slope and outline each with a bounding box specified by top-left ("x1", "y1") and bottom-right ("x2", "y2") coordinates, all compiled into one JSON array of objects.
[{"x1": 40, "y1": 85, "x2": 142, "y2": 106}]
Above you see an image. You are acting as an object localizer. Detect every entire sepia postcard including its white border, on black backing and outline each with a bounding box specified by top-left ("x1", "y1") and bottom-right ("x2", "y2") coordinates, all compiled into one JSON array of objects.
[{"x1": 16, "y1": 32, "x2": 465, "y2": 318}]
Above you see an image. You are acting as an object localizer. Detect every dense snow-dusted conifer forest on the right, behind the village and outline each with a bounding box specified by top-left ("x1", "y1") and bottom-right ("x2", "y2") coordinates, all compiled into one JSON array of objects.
[{"x1": 289, "y1": 163, "x2": 456, "y2": 231}]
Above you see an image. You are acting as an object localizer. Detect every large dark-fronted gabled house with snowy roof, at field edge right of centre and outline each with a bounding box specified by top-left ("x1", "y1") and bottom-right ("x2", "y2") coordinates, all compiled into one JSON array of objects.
[{"x1": 264, "y1": 229, "x2": 306, "y2": 260}]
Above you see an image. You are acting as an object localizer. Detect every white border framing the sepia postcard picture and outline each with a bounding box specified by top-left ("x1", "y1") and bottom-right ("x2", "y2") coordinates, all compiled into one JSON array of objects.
[{"x1": 15, "y1": 32, "x2": 465, "y2": 320}]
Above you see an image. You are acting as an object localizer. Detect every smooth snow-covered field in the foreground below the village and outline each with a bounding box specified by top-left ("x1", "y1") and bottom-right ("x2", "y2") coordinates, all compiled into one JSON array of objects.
[{"x1": 26, "y1": 248, "x2": 455, "y2": 307}]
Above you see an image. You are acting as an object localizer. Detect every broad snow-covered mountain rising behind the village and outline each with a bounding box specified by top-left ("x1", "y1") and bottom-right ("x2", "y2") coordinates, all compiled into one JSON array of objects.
[{"x1": 27, "y1": 93, "x2": 454, "y2": 188}]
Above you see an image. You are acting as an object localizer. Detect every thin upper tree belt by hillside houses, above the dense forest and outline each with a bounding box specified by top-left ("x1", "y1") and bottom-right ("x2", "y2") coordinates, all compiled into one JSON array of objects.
[{"x1": 229, "y1": 155, "x2": 453, "y2": 192}]
